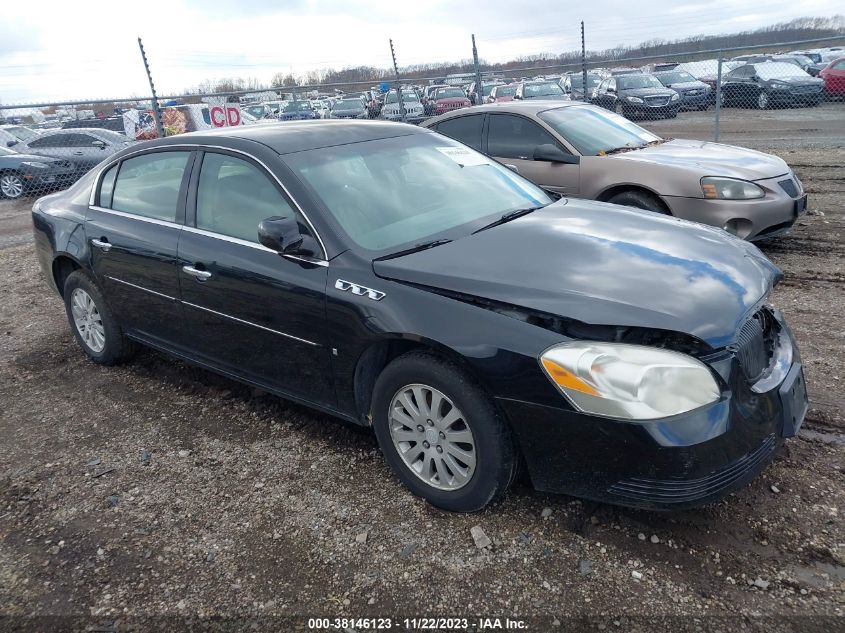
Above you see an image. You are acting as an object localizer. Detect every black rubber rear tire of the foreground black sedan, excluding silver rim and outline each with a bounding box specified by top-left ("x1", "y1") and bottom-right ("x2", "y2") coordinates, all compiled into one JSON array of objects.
[{"x1": 63, "y1": 270, "x2": 136, "y2": 365}]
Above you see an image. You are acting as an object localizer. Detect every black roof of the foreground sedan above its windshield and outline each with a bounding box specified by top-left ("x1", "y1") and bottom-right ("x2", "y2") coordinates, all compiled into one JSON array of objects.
[{"x1": 147, "y1": 119, "x2": 429, "y2": 154}]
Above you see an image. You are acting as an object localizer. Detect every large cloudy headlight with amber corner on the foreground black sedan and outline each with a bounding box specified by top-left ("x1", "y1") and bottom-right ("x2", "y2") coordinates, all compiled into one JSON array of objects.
[{"x1": 540, "y1": 341, "x2": 720, "y2": 420}]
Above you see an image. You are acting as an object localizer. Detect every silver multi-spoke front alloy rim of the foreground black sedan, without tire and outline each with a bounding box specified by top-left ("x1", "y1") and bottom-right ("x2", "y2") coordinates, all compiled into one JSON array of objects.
[{"x1": 388, "y1": 384, "x2": 476, "y2": 491}]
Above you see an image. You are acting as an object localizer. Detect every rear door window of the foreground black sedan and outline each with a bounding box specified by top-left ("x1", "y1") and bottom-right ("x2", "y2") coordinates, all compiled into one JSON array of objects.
[{"x1": 111, "y1": 152, "x2": 191, "y2": 222}]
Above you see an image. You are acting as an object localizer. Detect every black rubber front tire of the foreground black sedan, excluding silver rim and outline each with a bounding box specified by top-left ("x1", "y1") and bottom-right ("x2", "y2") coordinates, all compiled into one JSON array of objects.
[{"x1": 371, "y1": 351, "x2": 518, "y2": 512}]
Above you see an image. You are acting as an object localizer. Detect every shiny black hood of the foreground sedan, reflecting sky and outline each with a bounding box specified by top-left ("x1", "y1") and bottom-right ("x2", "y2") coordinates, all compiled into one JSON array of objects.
[{"x1": 373, "y1": 200, "x2": 781, "y2": 347}]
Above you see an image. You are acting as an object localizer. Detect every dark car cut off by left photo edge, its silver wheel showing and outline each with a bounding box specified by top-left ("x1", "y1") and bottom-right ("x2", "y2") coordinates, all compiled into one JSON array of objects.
[{"x1": 0, "y1": 147, "x2": 74, "y2": 198}]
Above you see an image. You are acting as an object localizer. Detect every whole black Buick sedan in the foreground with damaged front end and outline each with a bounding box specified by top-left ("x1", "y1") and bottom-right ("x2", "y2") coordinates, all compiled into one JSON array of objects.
[{"x1": 33, "y1": 121, "x2": 807, "y2": 511}]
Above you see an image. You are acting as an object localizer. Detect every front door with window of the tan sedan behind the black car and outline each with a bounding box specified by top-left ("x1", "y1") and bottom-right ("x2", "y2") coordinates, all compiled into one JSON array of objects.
[{"x1": 485, "y1": 114, "x2": 580, "y2": 195}]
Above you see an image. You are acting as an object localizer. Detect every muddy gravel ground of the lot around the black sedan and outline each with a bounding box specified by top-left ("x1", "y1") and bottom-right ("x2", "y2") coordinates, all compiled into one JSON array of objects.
[{"x1": 0, "y1": 116, "x2": 845, "y2": 631}]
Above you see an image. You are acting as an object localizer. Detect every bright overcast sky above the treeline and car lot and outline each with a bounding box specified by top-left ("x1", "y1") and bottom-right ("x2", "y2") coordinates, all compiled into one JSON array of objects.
[{"x1": 0, "y1": 0, "x2": 843, "y2": 104}]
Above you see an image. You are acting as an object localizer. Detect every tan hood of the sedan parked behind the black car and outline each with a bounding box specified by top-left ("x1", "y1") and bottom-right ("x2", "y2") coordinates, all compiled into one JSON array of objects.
[{"x1": 609, "y1": 139, "x2": 789, "y2": 180}]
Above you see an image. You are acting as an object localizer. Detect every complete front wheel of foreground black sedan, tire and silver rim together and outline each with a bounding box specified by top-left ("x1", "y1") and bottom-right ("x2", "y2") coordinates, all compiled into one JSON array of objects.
[{"x1": 372, "y1": 351, "x2": 518, "y2": 512}]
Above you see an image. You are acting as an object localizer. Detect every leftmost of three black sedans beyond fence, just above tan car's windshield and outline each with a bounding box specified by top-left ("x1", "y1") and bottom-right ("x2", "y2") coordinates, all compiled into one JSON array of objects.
[{"x1": 593, "y1": 74, "x2": 681, "y2": 119}]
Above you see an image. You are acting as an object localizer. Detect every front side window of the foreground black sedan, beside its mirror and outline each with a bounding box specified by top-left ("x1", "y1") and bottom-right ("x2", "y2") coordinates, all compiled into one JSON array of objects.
[{"x1": 197, "y1": 153, "x2": 293, "y2": 243}]
